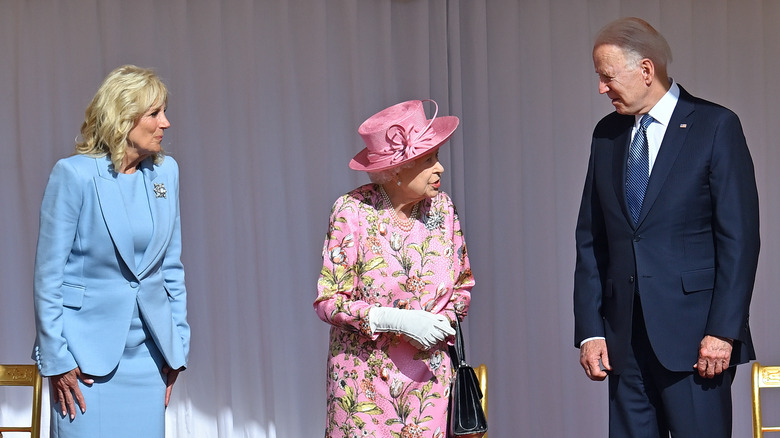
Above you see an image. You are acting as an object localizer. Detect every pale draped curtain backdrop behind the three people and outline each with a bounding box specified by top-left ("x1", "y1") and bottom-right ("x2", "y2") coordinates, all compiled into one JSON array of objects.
[{"x1": 0, "y1": 0, "x2": 780, "y2": 438}]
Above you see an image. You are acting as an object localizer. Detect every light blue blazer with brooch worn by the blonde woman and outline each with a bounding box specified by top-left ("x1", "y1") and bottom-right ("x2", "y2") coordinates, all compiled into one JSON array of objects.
[{"x1": 33, "y1": 155, "x2": 190, "y2": 376}]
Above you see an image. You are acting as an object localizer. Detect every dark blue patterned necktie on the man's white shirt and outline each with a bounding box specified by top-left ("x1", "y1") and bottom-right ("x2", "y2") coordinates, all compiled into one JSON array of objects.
[{"x1": 626, "y1": 114, "x2": 654, "y2": 224}]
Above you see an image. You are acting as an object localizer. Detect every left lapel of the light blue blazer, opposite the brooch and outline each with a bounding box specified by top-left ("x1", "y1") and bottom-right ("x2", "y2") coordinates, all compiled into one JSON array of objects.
[{"x1": 95, "y1": 157, "x2": 136, "y2": 275}]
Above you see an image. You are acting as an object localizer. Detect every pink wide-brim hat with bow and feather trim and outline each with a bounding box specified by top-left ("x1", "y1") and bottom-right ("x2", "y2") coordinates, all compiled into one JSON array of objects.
[{"x1": 349, "y1": 99, "x2": 460, "y2": 172}]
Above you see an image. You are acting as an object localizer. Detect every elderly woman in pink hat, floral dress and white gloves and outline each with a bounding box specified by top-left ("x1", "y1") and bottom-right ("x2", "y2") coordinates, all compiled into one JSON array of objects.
[{"x1": 314, "y1": 100, "x2": 474, "y2": 438}]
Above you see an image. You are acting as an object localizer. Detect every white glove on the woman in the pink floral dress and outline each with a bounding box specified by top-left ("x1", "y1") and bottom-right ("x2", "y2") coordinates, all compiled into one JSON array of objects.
[{"x1": 368, "y1": 307, "x2": 455, "y2": 350}]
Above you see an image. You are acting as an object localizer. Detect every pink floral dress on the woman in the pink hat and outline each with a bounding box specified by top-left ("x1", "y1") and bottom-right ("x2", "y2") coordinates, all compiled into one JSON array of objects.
[{"x1": 314, "y1": 184, "x2": 474, "y2": 438}]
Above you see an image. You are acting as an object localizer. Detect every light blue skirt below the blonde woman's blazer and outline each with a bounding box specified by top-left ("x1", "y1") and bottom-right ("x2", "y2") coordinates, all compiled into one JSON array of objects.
[{"x1": 51, "y1": 306, "x2": 165, "y2": 438}]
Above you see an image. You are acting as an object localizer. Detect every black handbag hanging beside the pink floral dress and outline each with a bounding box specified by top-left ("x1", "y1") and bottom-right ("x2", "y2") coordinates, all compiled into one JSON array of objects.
[{"x1": 449, "y1": 318, "x2": 487, "y2": 438}]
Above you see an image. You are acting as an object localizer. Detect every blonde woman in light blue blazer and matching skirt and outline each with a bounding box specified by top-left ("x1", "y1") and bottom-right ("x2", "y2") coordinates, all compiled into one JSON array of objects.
[{"x1": 33, "y1": 65, "x2": 190, "y2": 437}]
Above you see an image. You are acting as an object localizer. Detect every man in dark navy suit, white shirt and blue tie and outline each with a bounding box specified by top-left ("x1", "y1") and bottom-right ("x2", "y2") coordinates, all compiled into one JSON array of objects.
[{"x1": 574, "y1": 18, "x2": 759, "y2": 438}]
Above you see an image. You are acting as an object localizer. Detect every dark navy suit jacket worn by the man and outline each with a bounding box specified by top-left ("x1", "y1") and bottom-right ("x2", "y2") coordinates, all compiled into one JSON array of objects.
[{"x1": 574, "y1": 87, "x2": 759, "y2": 374}]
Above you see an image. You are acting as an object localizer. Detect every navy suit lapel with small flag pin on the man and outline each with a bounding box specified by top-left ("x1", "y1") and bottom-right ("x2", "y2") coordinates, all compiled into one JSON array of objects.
[{"x1": 639, "y1": 91, "x2": 694, "y2": 224}]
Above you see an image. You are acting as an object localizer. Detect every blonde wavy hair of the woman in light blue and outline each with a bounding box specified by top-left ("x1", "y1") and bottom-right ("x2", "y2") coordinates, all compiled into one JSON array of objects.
[{"x1": 76, "y1": 65, "x2": 168, "y2": 171}]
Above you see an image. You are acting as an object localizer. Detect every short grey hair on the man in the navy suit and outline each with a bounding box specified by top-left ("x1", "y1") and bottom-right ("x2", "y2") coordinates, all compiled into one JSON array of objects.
[{"x1": 593, "y1": 17, "x2": 672, "y2": 71}]
